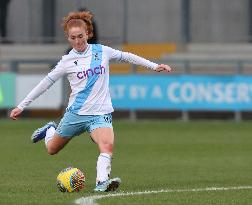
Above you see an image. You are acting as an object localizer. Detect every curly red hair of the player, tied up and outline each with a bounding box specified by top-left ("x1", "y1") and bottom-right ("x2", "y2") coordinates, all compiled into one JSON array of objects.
[{"x1": 62, "y1": 11, "x2": 93, "y2": 39}]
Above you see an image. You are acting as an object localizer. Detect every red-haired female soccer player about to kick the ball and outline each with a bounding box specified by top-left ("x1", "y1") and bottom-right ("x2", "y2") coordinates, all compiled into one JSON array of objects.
[{"x1": 10, "y1": 11, "x2": 171, "y2": 192}]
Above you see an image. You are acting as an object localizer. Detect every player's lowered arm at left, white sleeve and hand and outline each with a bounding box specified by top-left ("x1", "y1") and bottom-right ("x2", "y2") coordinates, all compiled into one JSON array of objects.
[{"x1": 10, "y1": 60, "x2": 65, "y2": 120}]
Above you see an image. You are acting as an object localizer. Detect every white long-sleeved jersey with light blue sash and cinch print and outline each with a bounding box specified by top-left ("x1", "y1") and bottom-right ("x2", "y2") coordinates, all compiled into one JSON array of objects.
[{"x1": 18, "y1": 44, "x2": 157, "y2": 115}]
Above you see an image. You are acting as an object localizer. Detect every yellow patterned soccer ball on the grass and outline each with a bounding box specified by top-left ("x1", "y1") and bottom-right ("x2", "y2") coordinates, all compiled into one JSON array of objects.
[{"x1": 57, "y1": 167, "x2": 85, "y2": 192}]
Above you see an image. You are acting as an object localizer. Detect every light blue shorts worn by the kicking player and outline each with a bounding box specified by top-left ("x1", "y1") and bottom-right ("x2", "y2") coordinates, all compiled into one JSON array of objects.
[{"x1": 56, "y1": 112, "x2": 112, "y2": 138}]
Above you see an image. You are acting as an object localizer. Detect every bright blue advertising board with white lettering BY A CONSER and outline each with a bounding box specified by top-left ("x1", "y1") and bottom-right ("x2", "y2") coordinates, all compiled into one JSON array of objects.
[{"x1": 110, "y1": 75, "x2": 252, "y2": 111}]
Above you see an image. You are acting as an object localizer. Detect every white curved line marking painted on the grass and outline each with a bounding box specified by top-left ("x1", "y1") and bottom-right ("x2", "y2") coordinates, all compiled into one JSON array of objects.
[{"x1": 75, "y1": 186, "x2": 252, "y2": 205}]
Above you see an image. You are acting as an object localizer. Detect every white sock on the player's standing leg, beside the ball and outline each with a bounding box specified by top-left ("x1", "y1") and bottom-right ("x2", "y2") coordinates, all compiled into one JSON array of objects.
[{"x1": 96, "y1": 153, "x2": 112, "y2": 184}]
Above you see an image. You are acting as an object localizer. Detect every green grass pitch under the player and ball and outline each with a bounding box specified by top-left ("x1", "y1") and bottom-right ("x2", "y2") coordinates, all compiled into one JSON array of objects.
[{"x1": 0, "y1": 119, "x2": 252, "y2": 205}]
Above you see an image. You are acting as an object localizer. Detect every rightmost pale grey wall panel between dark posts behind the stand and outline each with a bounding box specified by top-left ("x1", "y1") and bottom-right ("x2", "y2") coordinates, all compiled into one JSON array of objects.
[{"x1": 191, "y1": 0, "x2": 249, "y2": 42}]
